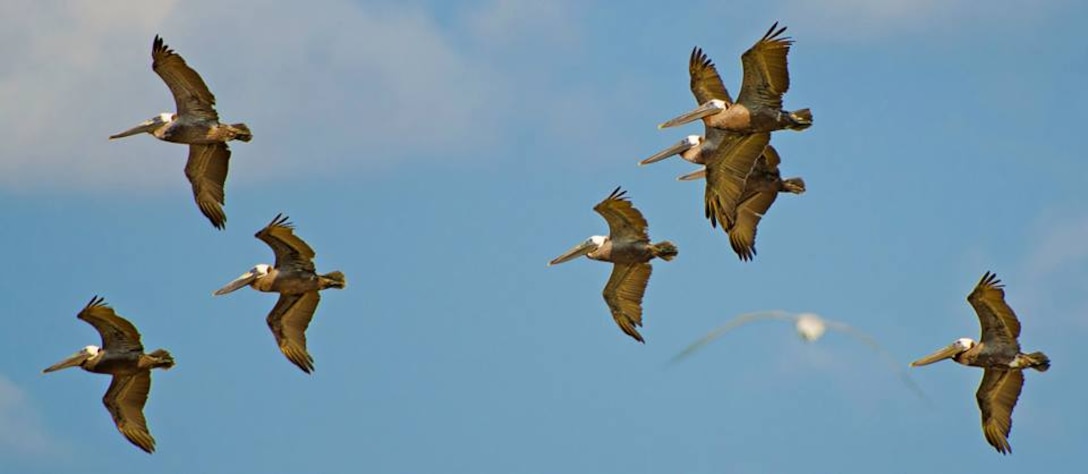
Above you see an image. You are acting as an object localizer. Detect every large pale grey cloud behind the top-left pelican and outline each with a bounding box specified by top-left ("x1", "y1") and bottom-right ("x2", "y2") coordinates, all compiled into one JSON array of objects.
[{"x1": 0, "y1": 0, "x2": 587, "y2": 192}]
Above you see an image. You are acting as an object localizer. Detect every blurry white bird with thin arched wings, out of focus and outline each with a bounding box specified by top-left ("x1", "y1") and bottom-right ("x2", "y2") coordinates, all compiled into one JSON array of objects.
[{"x1": 672, "y1": 311, "x2": 929, "y2": 401}]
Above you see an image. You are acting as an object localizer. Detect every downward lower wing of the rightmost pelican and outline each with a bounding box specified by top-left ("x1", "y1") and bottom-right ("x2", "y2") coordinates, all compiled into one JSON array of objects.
[{"x1": 975, "y1": 369, "x2": 1024, "y2": 454}]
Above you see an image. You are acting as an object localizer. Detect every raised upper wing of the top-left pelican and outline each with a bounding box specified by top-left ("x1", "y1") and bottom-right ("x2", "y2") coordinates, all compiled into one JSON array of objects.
[{"x1": 151, "y1": 35, "x2": 219, "y2": 122}]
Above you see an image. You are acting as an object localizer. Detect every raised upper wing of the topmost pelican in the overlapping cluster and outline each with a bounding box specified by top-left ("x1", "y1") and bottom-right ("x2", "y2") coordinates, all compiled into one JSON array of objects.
[{"x1": 737, "y1": 22, "x2": 793, "y2": 110}]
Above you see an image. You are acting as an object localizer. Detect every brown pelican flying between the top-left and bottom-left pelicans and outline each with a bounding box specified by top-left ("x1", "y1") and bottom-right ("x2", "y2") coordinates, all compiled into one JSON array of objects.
[{"x1": 213, "y1": 214, "x2": 347, "y2": 373}]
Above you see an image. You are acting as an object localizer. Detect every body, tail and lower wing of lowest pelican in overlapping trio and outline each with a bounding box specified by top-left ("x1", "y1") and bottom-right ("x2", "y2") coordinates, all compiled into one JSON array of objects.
[{"x1": 729, "y1": 145, "x2": 805, "y2": 261}]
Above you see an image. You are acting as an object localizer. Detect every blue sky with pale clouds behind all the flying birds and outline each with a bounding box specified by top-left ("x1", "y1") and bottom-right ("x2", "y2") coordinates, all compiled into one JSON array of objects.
[{"x1": 0, "y1": 0, "x2": 1088, "y2": 474}]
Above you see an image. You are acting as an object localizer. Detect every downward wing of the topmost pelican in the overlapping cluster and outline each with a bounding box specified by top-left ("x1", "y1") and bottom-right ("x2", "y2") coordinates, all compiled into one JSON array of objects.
[{"x1": 704, "y1": 133, "x2": 770, "y2": 232}]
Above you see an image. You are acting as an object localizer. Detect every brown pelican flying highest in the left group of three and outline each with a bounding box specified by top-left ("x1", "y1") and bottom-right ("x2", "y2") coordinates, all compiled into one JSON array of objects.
[{"x1": 110, "y1": 35, "x2": 254, "y2": 229}]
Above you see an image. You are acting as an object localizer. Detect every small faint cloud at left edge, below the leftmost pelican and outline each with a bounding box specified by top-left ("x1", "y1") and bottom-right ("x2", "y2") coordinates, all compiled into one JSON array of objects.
[{"x1": 0, "y1": 375, "x2": 52, "y2": 456}]
